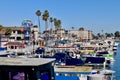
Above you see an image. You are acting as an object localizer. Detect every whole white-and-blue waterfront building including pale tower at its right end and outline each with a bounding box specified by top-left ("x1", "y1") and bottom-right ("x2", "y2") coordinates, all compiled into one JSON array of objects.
[{"x1": 6, "y1": 26, "x2": 38, "y2": 49}]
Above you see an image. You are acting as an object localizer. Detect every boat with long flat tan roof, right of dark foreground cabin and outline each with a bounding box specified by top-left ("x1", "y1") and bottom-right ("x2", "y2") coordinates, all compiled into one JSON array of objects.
[{"x1": 54, "y1": 65, "x2": 92, "y2": 80}]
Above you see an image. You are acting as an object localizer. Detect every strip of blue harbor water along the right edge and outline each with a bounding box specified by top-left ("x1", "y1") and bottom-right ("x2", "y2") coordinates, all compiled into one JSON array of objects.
[{"x1": 110, "y1": 44, "x2": 120, "y2": 80}]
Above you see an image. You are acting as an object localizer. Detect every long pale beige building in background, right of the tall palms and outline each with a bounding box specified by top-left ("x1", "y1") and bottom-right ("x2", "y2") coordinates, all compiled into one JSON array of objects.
[{"x1": 51, "y1": 29, "x2": 92, "y2": 41}]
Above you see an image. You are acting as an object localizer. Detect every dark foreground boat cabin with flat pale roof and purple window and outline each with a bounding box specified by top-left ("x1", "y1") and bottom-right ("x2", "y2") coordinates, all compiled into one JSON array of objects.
[{"x1": 0, "y1": 57, "x2": 55, "y2": 80}]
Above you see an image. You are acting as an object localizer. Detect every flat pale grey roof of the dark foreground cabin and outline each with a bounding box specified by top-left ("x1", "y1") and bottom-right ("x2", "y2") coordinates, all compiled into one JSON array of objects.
[{"x1": 0, "y1": 57, "x2": 55, "y2": 66}]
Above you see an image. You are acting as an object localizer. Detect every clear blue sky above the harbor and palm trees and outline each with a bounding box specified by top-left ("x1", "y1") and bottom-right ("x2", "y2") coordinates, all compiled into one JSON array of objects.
[{"x1": 0, "y1": 0, "x2": 120, "y2": 34}]
